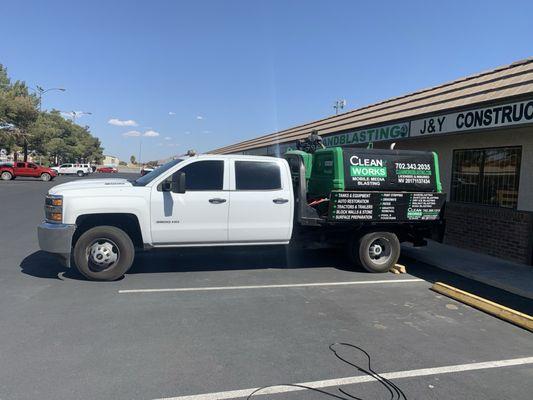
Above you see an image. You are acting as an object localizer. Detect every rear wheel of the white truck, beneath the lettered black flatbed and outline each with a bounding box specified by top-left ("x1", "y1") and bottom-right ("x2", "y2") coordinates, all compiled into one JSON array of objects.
[{"x1": 349, "y1": 232, "x2": 400, "y2": 273}]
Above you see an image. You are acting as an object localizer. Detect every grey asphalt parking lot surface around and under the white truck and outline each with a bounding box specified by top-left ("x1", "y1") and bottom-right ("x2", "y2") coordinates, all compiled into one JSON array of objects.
[{"x1": 0, "y1": 175, "x2": 533, "y2": 400}]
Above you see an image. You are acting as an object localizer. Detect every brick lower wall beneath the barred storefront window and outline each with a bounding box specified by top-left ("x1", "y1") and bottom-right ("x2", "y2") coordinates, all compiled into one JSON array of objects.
[{"x1": 444, "y1": 203, "x2": 533, "y2": 264}]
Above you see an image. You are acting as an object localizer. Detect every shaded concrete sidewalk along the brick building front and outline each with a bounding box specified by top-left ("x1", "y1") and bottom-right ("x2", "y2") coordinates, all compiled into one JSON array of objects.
[{"x1": 402, "y1": 240, "x2": 533, "y2": 299}]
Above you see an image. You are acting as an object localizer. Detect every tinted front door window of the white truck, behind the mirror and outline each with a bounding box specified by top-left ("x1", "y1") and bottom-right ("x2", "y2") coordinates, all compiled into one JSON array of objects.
[{"x1": 180, "y1": 160, "x2": 224, "y2": 190}]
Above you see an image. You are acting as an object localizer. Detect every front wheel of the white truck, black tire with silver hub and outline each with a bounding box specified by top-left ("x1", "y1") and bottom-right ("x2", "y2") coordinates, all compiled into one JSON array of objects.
[{"x1": 73, "y1": 225, "x2": 135, "y2": 281}]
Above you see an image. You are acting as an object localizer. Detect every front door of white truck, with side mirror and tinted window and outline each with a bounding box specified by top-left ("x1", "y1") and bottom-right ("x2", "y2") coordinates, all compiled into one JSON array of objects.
[{"x1": 150, "y1": 159, "x2": 229, "y2": 244}]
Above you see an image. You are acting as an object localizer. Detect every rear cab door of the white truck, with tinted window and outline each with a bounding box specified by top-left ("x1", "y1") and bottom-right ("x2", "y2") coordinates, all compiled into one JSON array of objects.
[{"x1": 229, "y1": 160, "x2": 294, "y2": 242}]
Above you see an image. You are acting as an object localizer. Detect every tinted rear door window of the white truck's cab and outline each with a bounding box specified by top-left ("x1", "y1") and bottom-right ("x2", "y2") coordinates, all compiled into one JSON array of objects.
[{"x1": 235, "y1": 161, "x2": 281, "y2": 190}]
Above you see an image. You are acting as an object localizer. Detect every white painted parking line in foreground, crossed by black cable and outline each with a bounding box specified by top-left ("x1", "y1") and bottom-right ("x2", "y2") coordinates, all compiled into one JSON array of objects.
[{"x1": 153, "y1": 357, "x2": 533, "y2": 400}]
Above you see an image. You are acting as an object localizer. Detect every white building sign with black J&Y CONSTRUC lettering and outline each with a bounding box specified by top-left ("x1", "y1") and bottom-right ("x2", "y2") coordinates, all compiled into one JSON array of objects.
[{"x1": 411, "y1": 100, "x2": 533, "y2": 136}]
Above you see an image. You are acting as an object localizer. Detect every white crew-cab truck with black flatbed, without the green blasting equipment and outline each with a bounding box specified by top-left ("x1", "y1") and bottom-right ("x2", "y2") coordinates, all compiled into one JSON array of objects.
[{"x1": 38, "y1": 155, "x2": 444, "y2": 280}]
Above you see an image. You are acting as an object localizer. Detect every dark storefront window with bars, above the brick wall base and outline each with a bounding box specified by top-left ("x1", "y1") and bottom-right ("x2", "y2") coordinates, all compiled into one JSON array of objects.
[{"x1": 450, "y1": 146, "x2": 522, "y2": 208}]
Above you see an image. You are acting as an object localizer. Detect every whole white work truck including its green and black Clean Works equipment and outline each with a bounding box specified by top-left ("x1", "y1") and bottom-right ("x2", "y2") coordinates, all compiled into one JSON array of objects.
[{"x1": 38, "y1": 141, "x2": 444, "y2": 280}]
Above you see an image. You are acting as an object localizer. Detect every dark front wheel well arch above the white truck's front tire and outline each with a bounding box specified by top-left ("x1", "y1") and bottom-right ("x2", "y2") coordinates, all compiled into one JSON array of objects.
[{"x1": 72, "y1": 213, "x2": 143, "y2": 248}]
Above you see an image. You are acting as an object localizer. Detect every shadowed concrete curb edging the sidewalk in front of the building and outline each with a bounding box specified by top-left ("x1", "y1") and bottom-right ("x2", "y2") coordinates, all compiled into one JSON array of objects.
[{"x1": 402, "y1": 246, "x2": 533, "y2": 300}]
